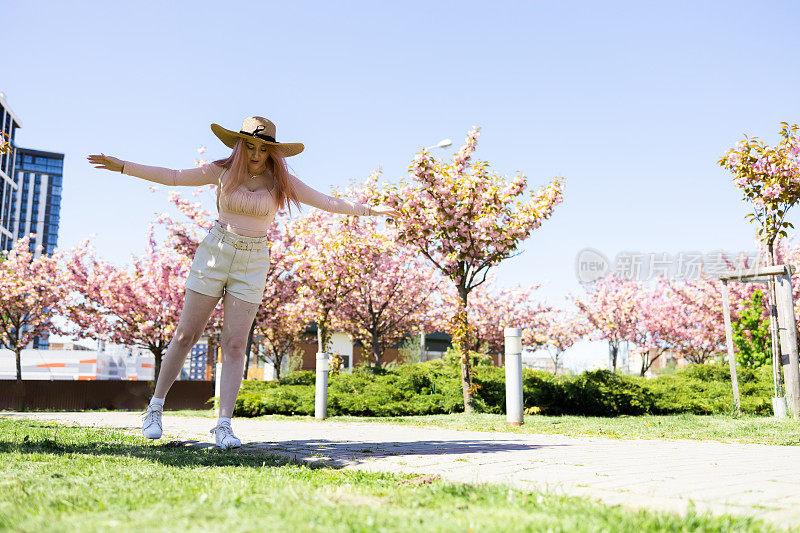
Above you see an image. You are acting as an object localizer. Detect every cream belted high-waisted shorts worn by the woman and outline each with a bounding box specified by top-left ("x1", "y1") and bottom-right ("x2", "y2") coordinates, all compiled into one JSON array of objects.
[{"x1": 186, "y1": 222, "x2": 269, "y2": 304}]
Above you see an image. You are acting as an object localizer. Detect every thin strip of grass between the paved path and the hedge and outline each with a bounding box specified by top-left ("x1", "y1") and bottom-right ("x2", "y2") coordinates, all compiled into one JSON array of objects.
[{"x1": 162, "y1": 411, "x2": 800, "y2": 446}]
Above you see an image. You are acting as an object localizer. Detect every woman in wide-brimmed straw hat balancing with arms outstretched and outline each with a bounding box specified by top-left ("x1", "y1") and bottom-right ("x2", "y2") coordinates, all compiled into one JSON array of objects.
[{"x1": 88, "y1": 117, "x2": 400, "y2": 449}]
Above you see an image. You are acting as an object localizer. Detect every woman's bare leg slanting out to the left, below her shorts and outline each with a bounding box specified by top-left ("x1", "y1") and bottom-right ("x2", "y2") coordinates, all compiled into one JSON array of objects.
[{"x1": 153, "y1": 289, "x2": 219, "y2": 398}]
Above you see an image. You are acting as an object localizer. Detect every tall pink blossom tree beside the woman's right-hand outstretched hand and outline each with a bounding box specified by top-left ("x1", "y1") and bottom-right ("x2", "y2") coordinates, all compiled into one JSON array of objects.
[{"x1": 375, "y1": 128, "x2": 562, "y2": 412}]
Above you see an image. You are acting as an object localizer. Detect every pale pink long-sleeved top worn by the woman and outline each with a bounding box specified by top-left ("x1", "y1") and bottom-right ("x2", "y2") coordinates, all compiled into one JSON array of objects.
[{"x1": 122, "y1": 161, "x2": 372, "y2": 237}]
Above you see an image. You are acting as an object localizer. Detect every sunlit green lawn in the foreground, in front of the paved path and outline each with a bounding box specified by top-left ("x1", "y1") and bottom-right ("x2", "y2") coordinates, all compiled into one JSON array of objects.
[{"x1": 0, "y1": 418, "x2": 777, "y2": 532}]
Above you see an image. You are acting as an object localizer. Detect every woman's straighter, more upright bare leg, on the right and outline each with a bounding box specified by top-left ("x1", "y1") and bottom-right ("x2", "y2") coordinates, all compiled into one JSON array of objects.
[{"x1": 219, "y1": 294, "x2": 258, "y2": 418}]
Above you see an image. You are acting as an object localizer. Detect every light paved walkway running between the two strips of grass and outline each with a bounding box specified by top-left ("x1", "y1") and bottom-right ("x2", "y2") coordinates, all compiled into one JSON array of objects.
[{"x1": 6, "y1": 412, "x2": 800, "y2": 528}]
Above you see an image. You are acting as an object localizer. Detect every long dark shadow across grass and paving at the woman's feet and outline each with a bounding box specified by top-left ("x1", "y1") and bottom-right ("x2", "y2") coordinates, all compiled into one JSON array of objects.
[{"x1": 0, "y1": 419, "x2": 568, "y2": 469}]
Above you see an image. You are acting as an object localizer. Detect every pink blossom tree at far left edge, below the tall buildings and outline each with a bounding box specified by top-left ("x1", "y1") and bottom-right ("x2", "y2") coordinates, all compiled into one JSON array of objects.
[{"x1": 0, "y1": 237, "x2": 70, "y2": 381}]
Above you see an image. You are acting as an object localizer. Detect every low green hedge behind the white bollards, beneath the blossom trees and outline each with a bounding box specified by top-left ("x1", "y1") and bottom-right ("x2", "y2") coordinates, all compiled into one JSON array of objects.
[{"x1": 234, "y1": 360, "x2": 772, "y2": 416}]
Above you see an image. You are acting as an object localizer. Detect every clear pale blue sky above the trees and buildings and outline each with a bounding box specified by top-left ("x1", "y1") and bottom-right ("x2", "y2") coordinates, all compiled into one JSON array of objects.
[{"x1": 6, "y1": 0, "x2": 800, "y2": 368}]
